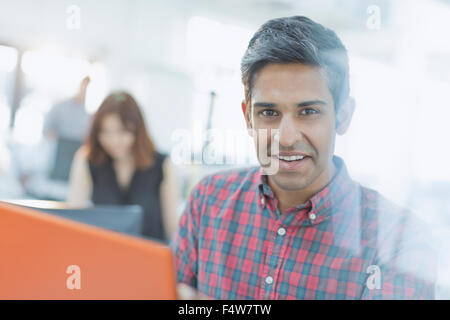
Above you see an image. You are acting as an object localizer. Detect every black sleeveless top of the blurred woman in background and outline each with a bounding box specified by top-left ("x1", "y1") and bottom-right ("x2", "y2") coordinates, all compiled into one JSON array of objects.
[{"x1": 89, "y1": 152, "x2": 166, "y2": 241}]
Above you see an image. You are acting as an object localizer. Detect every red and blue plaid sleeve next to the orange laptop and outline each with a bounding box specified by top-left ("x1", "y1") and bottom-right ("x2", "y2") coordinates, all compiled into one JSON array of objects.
[{"x1": 171, "y1": 180, "x2": 209, "y2": 289}]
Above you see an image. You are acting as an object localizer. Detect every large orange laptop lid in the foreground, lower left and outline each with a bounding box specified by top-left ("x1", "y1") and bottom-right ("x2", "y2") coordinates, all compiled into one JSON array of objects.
[{"x1": 0, "y1": 203, "x2": 176, "y2": 300}]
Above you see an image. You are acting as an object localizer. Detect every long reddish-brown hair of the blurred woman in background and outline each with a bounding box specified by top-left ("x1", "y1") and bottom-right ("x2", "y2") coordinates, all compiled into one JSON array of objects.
[{"x1": 85, "y1": 92, "x2": 156, "y2": 169}]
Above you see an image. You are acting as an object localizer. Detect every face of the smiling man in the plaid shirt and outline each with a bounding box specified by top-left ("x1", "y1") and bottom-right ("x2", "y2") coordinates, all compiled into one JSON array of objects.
[{"x1": 245, "y1": 64, "x2": 336, "y2": 190}]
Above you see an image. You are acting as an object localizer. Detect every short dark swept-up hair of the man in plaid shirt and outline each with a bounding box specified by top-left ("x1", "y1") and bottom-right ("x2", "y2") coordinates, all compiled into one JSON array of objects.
[{"x1": 241, "y1": 16, "x2": 350, "y2": 111}]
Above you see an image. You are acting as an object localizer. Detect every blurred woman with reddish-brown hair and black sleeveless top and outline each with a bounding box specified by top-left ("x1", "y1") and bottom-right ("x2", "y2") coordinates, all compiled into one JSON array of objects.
[{"x1": 68, "y1": 92, "x2": 180, "y2": 241}]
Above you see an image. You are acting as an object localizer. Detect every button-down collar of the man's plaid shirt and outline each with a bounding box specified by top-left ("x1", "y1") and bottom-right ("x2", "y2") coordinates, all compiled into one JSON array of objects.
[{"x1": 256, "y1": 156, "x2": 356, "y2": 223}]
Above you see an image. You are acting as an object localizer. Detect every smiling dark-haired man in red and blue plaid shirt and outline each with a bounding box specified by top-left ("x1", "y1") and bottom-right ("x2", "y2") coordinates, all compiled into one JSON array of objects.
[{"x1": 172, "y1": 16, "x2": 436, "y2": 299}]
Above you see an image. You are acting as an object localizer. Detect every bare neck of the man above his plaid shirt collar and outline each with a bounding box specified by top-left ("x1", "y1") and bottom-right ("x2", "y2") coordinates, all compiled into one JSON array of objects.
[{"x1": 268, "y1": 161, "x2": 337, "y2": 213}]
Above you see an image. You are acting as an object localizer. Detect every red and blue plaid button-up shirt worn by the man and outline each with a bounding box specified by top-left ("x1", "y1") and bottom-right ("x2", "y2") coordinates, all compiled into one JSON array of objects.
[{"x1": 171, "y1": 157, "x2": 436, "y2": 299}]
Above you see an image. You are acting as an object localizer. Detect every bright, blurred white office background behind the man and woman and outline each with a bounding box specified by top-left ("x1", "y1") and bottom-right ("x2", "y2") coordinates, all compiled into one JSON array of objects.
[{"x1": 0, "y1": 0, "x2": 450, "y2": 298}]
